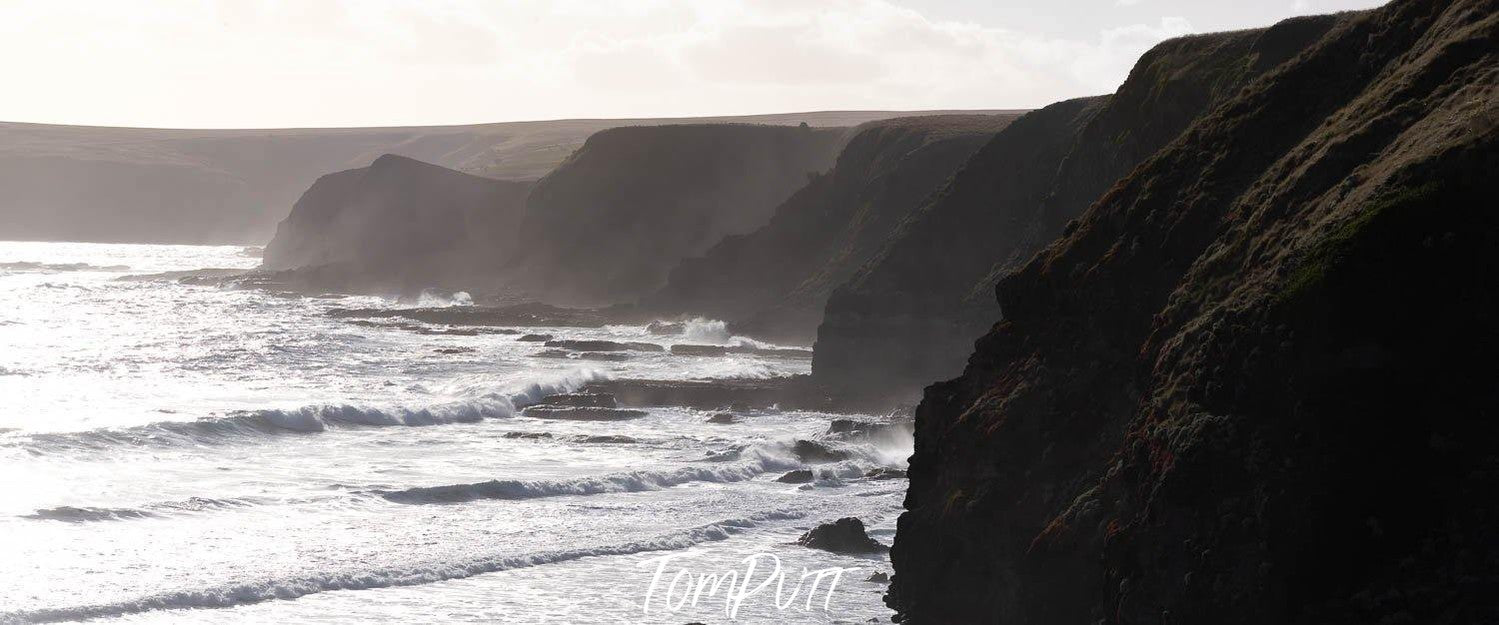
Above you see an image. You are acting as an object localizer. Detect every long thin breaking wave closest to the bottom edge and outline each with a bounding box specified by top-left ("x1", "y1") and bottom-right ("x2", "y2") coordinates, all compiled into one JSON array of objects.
[{"x1": 0, "y1": 510, "x2": 805, "y2": 622}]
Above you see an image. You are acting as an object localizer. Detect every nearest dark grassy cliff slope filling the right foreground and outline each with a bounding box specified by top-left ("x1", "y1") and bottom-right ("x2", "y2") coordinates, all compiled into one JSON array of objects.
[{"x1": 887, "y1": 0, "x2": 1499, "y2": 624}]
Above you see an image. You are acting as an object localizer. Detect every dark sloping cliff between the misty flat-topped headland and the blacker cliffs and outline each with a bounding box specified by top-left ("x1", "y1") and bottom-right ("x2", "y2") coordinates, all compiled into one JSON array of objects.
[{"x1": 645, "y1": 115, "x2": 1016, "y2": 342}]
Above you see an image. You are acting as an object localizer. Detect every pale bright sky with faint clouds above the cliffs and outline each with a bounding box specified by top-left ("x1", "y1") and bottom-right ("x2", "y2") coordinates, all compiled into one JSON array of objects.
[{"x1": 0, "y1": 0, "x2": 1381, "y2": 127}]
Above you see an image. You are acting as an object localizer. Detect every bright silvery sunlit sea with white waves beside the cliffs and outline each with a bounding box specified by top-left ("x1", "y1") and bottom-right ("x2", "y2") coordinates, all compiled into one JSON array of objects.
[{"x1": 0, "y1": 243, "x2": 910, "y2": 624}]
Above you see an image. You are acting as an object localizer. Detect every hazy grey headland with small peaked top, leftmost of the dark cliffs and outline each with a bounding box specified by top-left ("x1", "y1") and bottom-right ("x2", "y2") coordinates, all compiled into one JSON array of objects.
[{"x1": 264, "y1": 154, "x2": 529, "y2": 288}]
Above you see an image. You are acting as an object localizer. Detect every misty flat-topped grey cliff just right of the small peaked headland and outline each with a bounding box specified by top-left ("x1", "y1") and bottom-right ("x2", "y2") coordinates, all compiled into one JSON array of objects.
[{"x1": 507, "y1": 124, "x2": 847, "y2": 303}]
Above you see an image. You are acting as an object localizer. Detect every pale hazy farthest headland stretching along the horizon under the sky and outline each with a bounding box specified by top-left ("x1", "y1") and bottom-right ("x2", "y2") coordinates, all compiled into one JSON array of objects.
[{"x1": 0, "y1": 111, "x2": 959, "y2": 244}]
